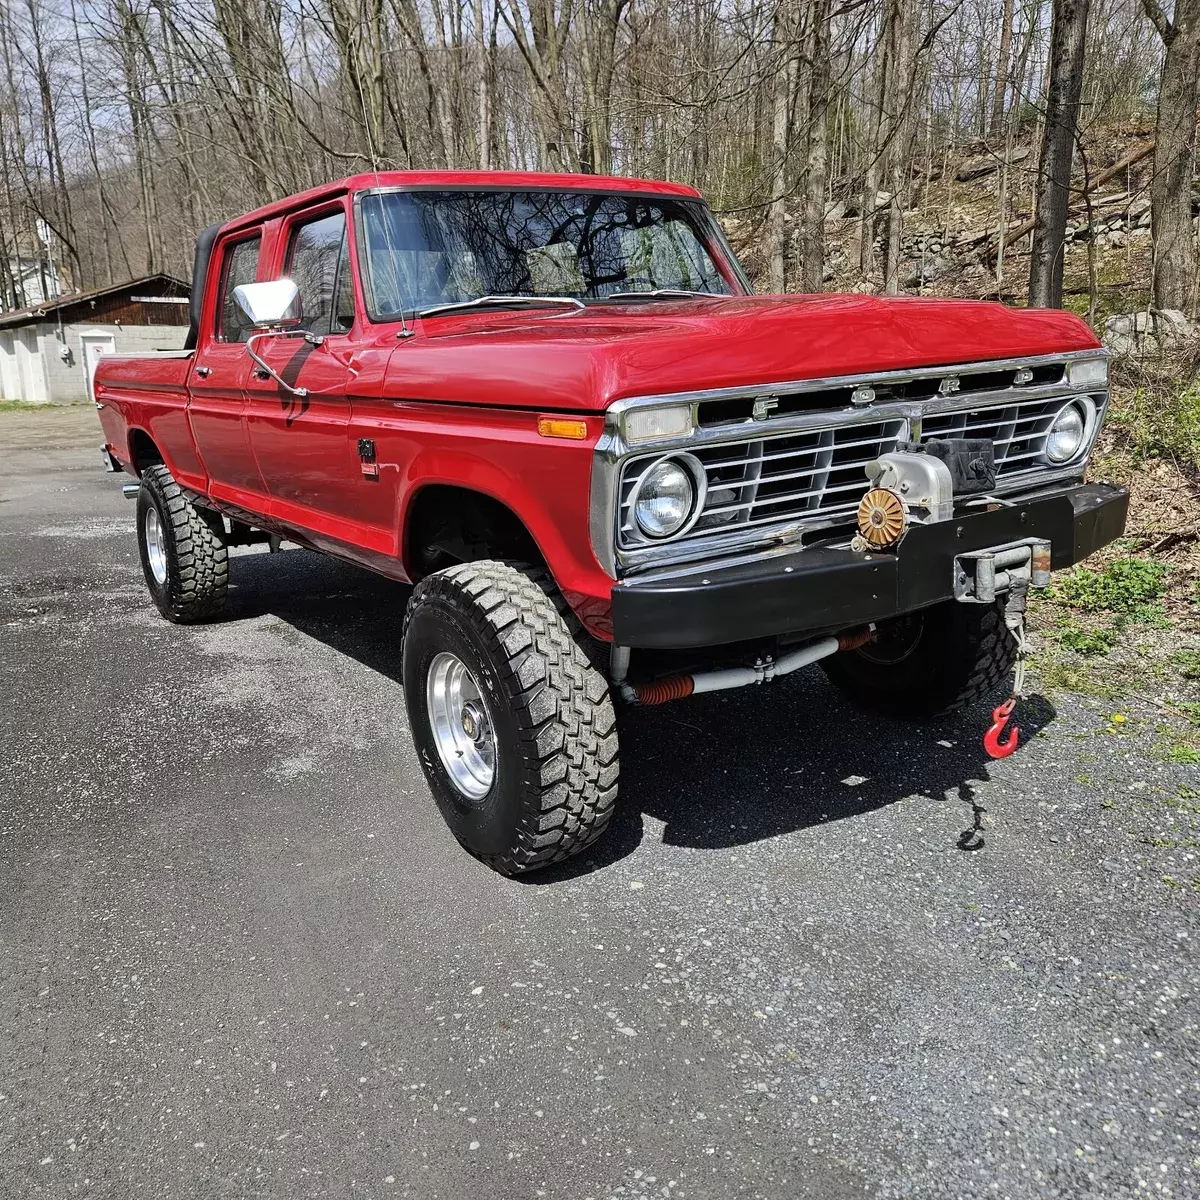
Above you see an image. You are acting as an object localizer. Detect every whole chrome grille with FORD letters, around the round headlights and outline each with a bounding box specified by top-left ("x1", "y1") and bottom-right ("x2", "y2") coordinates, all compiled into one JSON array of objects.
[{"x1": 604, "y1": 350, "x2": 1108, "y2": 577}]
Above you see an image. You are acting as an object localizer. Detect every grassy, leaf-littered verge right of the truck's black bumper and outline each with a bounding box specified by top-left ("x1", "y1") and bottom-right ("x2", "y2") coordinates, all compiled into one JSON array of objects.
[{"x1": 1031, "y1": 354, "x2": 1200, "y2": 893}]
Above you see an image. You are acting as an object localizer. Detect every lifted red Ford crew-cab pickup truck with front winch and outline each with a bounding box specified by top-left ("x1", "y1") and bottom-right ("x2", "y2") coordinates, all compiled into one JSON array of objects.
[{"x1": 95, "y1": 172, "x2": 1128, "y2": 872}]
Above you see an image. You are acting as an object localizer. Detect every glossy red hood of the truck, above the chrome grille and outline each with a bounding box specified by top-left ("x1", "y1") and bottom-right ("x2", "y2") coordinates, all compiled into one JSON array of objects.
[{"x1": 384, "y1": 295, "x2": 1099, "y2": 412}]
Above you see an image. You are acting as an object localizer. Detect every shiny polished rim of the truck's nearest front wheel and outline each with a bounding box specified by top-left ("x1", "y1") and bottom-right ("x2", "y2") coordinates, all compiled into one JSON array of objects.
[{"x1": 425, "y1": 650, "x2": 496, "y2": 800}]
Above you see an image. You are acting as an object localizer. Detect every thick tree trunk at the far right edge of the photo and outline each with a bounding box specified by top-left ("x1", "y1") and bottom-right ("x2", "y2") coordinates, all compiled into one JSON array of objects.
[{"x1": 1144, "y1": 0, "x2": 1200, "y2": 312}]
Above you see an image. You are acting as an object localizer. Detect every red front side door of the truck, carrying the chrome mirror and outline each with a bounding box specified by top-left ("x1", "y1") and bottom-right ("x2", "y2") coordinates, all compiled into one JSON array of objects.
[{"x1": 238, "y1": 204, "x2": 362, "y2": 542}]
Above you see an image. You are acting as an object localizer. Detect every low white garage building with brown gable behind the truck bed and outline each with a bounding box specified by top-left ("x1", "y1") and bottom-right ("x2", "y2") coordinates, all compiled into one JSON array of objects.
[{"x1": 0, "y1": 275, "x2": 188, "y2": 404}]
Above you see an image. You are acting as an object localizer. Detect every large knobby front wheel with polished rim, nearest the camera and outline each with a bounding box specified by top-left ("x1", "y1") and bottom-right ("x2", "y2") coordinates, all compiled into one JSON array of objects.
[{"x1": 403, "y1": 560, "x2": 619, "y2": 875}]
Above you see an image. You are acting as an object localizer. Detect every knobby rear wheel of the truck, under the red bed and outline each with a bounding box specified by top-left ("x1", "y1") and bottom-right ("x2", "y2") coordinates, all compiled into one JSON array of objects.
[{"x1": 138, "y1": 463, "x2": 229, "y2": 625}]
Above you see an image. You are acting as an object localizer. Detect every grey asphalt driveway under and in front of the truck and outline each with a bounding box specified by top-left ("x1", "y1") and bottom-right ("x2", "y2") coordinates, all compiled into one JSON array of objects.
[{"x1": 0, "y1": 410, "x2": 1200, "y2": 1200}]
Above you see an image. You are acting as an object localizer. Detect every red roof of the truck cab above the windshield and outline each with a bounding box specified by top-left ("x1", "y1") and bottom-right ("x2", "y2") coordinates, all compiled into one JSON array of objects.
[{"x1": 222, "y1": 170, "x2": 701, "y2": 229}]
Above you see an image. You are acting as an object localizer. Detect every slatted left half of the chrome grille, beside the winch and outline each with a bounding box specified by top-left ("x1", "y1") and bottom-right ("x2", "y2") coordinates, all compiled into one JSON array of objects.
[{"x1": 619, "y1": 418, "x2": 908, "y2": 546}]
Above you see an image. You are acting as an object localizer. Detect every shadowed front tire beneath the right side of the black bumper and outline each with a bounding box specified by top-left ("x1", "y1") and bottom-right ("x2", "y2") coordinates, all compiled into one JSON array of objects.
[{"x1": 821, "y1": 600, "x2": 1016, "y2": 720}]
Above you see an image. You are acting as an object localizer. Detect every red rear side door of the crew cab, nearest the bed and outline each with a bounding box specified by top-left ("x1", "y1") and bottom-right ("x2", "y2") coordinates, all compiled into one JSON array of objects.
[{"x1": 187, "y1": 230, "x2": 266, "y2": 512}]
